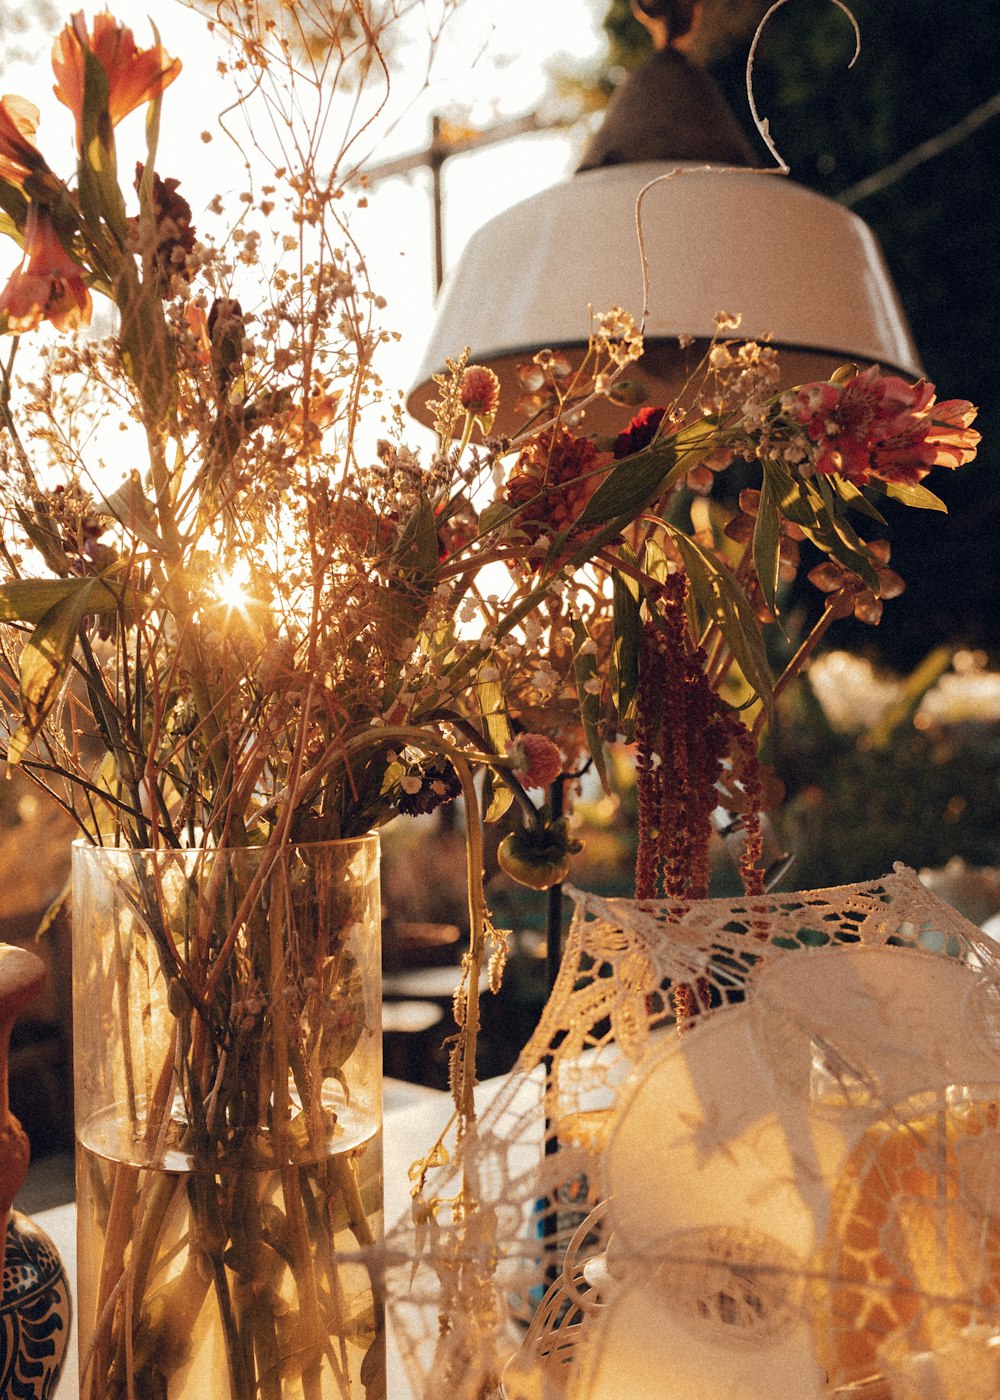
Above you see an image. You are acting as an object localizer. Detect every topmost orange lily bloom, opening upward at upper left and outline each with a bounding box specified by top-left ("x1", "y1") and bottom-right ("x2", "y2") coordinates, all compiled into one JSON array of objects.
[{"x1": 52, "y1": 11, "x2": 181, "y2": 146}]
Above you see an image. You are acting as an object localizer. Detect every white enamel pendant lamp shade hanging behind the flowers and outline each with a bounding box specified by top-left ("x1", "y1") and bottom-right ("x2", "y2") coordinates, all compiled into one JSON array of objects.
[{"x1": 408, "y1": 162, "x2": 922, "y2": 433}]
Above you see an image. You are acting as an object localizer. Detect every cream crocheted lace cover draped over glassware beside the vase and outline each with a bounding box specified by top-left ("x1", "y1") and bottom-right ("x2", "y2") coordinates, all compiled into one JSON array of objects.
[{"x1": 387, "y1": 867, "x2": 1000, "y2": 1400}]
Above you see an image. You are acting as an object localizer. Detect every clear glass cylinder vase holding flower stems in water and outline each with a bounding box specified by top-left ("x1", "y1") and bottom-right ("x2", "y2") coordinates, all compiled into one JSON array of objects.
[{"x1": 73, "y1": 836, "x2": 385, "y2": 1400}]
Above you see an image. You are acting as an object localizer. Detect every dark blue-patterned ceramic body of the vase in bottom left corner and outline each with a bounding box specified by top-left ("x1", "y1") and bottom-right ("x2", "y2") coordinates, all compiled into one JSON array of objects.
[{"x1": 0, "y1": 1211, "x2": 70, "y2": 1400}]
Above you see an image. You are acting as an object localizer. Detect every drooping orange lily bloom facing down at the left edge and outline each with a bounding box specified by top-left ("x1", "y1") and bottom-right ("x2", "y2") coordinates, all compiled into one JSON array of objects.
[{"x1": 0, "y1": 202, "x2": 91, "y2": 335}]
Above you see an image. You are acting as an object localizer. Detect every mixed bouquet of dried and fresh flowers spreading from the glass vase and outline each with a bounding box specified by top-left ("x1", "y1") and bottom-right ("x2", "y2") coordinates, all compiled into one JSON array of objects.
[{"x1": 0, "y1": 0, "x2": 978, "y2": 1396}]
